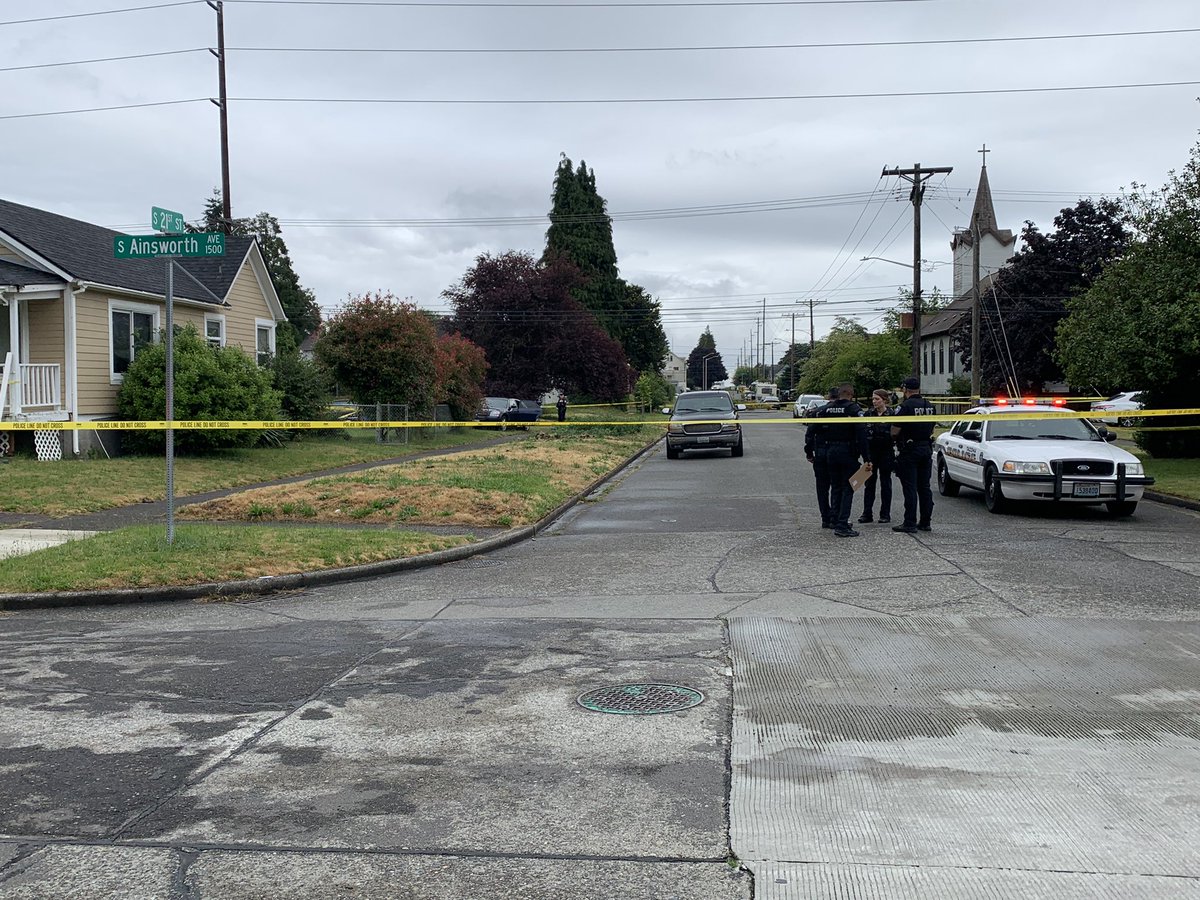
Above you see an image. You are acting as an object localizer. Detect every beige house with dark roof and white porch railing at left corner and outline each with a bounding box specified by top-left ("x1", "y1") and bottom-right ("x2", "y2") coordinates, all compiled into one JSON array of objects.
[{"x1": 0, "y1": 200, "x2": 287, "y2": 458}]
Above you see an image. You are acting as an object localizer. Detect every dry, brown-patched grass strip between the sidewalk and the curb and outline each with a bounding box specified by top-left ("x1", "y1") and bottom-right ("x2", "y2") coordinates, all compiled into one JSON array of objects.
[{"x1": 180, "y1": 434, "x2": 644, "y2": 528}]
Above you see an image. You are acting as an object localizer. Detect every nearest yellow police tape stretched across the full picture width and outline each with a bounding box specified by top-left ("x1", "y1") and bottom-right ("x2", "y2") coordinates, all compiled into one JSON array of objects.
[{"x1": 0, "y1": 406, "x2": 1200, "y2": 432}]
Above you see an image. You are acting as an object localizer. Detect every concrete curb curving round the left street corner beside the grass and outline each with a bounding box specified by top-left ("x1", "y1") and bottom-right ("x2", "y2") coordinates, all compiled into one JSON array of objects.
[{"x1": 0, "y1": 437, "x2": 664, "y2": 612}]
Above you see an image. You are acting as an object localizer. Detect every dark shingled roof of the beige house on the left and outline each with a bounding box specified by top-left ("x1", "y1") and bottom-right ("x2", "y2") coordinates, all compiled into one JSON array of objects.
[{"x1": 0, "y1": 199, "x2": 254, "y2": 306}]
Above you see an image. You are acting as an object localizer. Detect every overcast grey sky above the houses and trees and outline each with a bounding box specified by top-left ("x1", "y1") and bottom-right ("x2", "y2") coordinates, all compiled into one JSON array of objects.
[{"x1": 0, "y1": 0, "x2": 1200, "y2": 372}]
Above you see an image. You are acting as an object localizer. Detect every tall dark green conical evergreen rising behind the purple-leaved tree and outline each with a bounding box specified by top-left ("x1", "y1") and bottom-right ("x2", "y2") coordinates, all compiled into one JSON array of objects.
[{"x1": 542, "y1": 154, "x2": 668, "y2": 372}]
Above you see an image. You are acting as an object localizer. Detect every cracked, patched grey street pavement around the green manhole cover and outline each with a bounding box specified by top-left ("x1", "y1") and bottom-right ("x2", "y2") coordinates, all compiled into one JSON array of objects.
[{"x1": 0, "y1": 414, "x2": 1200, "y2": 900}]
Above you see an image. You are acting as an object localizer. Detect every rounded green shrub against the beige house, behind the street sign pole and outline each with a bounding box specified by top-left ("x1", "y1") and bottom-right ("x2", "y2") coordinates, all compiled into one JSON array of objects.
[{"x1": 116, "y1": 325, "x2": 280, "y2": 454}]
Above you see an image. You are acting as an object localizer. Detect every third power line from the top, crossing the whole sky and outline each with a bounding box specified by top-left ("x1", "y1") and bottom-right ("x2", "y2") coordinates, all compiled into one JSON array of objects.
[{"x1": 0, "y1": 79, "x2": 1200, "y2": 121}]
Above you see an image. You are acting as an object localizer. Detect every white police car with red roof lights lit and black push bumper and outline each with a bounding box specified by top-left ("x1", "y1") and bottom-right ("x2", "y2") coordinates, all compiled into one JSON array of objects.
[{"x1": 934, "y1": 406, "x2": 1154, "y2": 516}]
